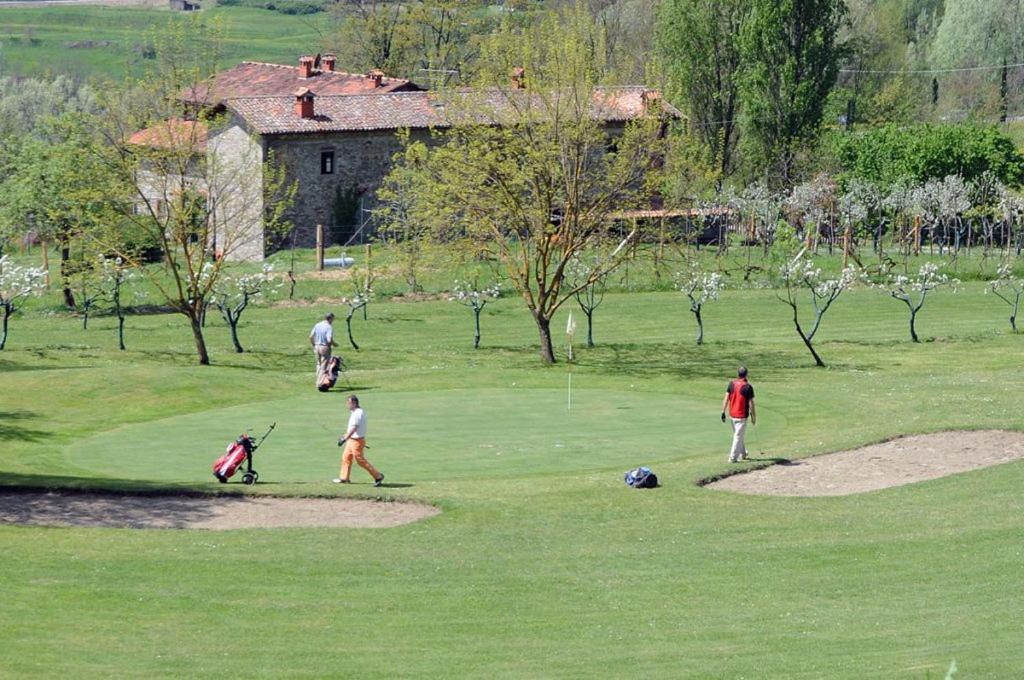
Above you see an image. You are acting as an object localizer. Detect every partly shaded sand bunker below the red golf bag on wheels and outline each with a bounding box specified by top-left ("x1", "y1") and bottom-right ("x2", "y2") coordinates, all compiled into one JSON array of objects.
[{"x1": 0, "y1": 490, "x2": 440, "y2": 529}]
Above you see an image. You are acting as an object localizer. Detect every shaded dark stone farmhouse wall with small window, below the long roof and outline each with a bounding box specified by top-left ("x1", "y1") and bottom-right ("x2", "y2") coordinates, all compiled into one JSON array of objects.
[{"x1": 265, "y1": 130, "x2": 431, "y2": 248}]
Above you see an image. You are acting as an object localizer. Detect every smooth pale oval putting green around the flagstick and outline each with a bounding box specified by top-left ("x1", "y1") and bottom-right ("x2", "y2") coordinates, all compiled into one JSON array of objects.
[{"x1": 66, "y1": 388, "x2": 753, "y2": 483}]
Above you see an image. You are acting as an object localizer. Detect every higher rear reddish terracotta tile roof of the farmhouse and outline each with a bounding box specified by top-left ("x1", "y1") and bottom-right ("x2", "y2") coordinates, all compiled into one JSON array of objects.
[{"x1": 182, "y1": 61, "x2": 419, "y2": 105}]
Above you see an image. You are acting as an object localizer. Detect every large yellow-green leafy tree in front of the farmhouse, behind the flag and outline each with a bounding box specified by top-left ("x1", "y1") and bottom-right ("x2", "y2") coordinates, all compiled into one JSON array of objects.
[{"x1": 380, "y1": 5, "x2": 666, "y2": 364}]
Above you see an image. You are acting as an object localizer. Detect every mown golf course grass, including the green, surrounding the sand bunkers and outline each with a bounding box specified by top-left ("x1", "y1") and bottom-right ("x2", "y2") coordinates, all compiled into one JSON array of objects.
[{"x1": 0, "y1": 284, "x2": 1024, "y2": 678}]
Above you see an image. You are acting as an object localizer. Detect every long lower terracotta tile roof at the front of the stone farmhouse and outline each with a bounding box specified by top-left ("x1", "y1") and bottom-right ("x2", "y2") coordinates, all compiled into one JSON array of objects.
[{"x1": 225, "y1": 87, "x2": 679, "y2": 134}]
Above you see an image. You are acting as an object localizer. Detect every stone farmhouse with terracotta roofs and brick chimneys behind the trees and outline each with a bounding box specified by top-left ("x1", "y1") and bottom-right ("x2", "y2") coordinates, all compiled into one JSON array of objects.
[{"x1": 132, "y1": 55, "x2": 674, "y2": 260}]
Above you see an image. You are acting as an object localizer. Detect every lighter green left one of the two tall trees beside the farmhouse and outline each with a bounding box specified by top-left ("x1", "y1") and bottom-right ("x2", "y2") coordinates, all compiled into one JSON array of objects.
[{"x1": 657, "y1": 0, "x2": 751, "y2": 183}]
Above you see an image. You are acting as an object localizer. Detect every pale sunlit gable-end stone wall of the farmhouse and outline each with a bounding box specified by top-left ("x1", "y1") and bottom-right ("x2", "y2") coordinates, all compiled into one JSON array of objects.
[{"x1": 207, "y1": 124, "x2": 266, "y2": 262}]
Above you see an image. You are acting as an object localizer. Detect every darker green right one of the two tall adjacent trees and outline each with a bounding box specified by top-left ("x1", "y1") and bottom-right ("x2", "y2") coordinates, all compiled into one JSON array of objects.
[{"x1": 739, "y1": 0, "x2": 847, "y2": 186}]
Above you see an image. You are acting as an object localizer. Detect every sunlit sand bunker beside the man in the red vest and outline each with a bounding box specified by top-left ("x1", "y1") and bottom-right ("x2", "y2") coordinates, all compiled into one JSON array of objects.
[{"x1": 708, "y1": 430, "x2": 1024, "y2": 496}]
